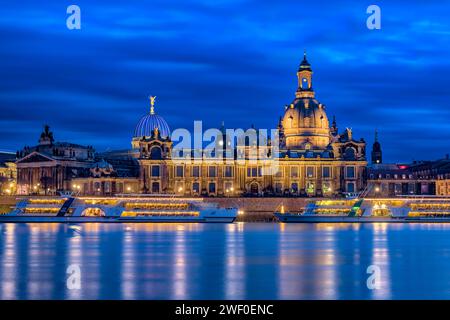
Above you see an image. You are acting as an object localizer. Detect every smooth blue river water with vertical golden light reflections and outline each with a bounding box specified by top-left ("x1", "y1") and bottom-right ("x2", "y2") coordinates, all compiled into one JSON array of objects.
[{"x1": 0, "y1": 223, "x2": 450, "y2": 299}]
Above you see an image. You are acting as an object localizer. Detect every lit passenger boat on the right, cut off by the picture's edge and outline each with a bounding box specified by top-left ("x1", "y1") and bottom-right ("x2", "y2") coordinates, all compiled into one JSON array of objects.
[{"x1": 274, "y1": 197, "x2": 450, "y2": 223}]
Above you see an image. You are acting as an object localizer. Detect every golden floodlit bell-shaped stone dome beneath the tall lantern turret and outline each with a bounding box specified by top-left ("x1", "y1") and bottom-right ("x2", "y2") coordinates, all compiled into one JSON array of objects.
[{"x1": 282, "y1": 98, "x2": 330, "y2": 149}]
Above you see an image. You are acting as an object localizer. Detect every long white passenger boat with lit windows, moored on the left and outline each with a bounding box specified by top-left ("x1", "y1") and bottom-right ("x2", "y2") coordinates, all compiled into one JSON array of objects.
[{"x1": 0, "y1": 196, "x2": 238, "y2": 223}]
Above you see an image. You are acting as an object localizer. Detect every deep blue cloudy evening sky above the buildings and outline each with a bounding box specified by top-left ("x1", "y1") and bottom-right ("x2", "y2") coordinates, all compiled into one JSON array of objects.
[{"x1": 0, "y1": 0, "x2": 450, "y2": 162}]
